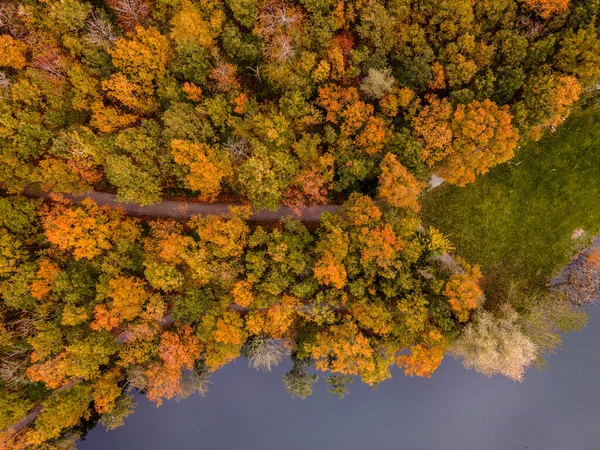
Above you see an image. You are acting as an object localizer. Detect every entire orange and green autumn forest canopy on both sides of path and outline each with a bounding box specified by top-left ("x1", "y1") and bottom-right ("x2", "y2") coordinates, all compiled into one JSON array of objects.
[{"x1": 0, "y1": 0, "x2": 600, "y2": 448}]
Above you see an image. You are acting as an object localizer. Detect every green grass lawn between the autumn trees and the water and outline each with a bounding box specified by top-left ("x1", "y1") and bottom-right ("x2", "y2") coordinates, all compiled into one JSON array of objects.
[{"x1": 423, "y1": 107, "x2": 600, "y2": 298}]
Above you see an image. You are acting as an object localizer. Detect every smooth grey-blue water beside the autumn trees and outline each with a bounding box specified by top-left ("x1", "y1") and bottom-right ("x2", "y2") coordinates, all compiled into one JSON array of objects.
[{"x1": 78, "y1": 308, "x2": 600, "y2": 450}]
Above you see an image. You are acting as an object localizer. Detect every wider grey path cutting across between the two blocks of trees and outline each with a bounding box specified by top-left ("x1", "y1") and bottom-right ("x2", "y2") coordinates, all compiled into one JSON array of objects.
[{"x1": 24, "y1": 191, "x2": 341, "y2": 222}]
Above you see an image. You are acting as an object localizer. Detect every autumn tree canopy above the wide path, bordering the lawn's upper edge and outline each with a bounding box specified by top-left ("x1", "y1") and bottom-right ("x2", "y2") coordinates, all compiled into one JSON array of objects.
[{"x1": 0, "y1": 0, "x2": 600, "y2": 208}]
